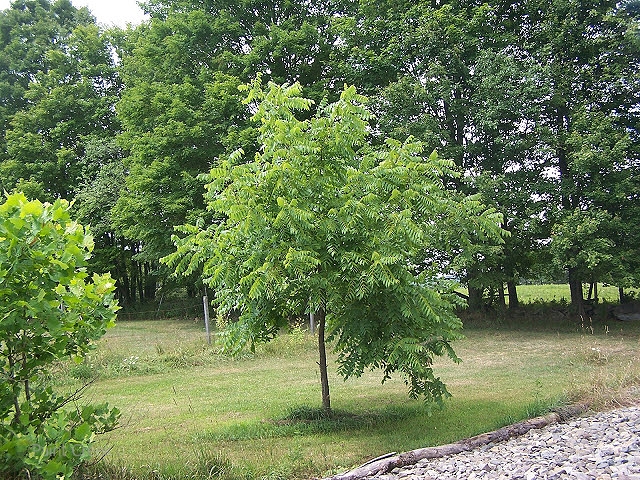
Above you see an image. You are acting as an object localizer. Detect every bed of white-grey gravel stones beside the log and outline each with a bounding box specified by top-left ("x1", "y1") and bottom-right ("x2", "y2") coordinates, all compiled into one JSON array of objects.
[{"x1": 360, "y1": 406, "x2": 640, "y2": 480}]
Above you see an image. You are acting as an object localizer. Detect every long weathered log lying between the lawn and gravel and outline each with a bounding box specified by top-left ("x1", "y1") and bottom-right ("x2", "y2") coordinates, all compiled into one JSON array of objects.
[{"x1": 325, "y1": 404, "x2": 589, "y2": 480}]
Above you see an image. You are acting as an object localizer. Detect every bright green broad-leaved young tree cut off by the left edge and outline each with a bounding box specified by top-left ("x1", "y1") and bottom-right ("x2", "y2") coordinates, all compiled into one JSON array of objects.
[{"x1": 0, "y1": 194, "x2": 118, "y2": 480}]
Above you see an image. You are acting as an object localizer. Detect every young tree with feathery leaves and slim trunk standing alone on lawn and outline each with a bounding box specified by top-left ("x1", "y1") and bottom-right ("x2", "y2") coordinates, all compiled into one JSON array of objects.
[{"x1": 163, "y1": 77, "x2": 501, "y2": 412}]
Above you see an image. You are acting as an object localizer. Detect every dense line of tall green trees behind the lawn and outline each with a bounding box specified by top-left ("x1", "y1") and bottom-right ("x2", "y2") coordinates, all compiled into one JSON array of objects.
[{"x1": 0, "y1": 0, "x2": 640, "y2": 313}]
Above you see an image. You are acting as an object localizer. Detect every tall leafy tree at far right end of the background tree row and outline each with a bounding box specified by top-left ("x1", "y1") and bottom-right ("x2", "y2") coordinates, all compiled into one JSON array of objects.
[{"x1": 521, "y1": 0, "x2": 640, "y2": 315}]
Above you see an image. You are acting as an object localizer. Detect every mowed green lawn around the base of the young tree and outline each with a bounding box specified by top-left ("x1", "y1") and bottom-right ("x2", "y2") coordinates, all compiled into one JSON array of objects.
[{"x1": 58, "y1": 302, "x2": 640, "y2": 479}]
